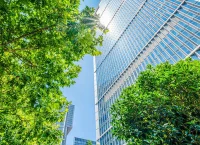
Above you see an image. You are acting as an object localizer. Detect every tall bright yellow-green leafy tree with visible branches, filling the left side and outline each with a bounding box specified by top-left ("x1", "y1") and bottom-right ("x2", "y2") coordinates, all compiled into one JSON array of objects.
[{"x1": 0, "y1": 0, "x2": 102, "y2": 145}]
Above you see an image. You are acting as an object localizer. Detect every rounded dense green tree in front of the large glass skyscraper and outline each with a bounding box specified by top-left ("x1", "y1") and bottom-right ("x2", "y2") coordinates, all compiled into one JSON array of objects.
[{"x1": 111, "y1": 59, "x2": 200, "y2": 145}]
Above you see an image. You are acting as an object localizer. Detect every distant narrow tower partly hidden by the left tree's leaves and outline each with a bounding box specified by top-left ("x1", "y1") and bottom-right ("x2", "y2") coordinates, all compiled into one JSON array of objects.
[{"x1": 59, "y1": 105, "x2": 74, "y2": 145}]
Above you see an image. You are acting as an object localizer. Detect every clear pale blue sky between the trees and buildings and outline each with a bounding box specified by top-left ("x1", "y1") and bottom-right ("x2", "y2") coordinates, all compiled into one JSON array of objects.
[{"x1": 62, "y1": 0, "x2": 100, "y2": 145}]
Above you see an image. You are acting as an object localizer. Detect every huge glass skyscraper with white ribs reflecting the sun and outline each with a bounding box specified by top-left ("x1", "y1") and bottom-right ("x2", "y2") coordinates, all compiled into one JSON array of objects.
[{"x1": 94, "y1": 0, "x2": 200, "y2": 145}]
